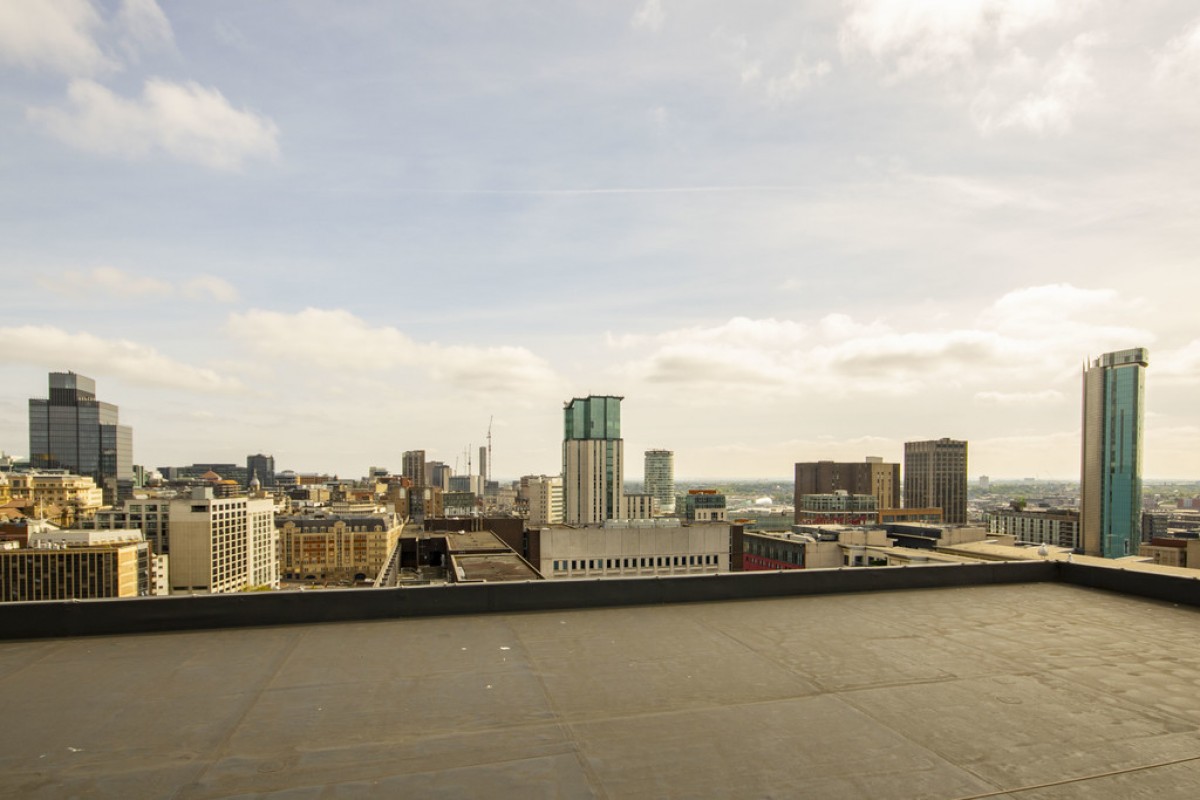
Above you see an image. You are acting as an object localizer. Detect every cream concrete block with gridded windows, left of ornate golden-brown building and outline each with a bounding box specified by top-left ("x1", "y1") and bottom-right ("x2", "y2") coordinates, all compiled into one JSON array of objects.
[{"x1": 170, "y1": 487, "x2": 280, "y2": 594}]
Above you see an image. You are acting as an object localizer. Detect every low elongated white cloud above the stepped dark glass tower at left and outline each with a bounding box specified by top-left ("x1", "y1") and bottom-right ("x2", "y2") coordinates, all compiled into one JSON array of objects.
[{"x1": 0, "y1": 325, "x2": 241, "y2": 392}]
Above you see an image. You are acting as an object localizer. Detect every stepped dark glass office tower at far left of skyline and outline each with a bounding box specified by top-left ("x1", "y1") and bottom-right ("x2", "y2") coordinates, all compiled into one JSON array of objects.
[{"x1": 29, "y1": 372, "x2": 133, "y2": 505}]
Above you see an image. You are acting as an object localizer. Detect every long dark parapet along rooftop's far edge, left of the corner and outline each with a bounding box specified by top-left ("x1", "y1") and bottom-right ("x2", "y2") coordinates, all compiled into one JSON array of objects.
[{"x1": 0, "y1": 561, "x2": 1060, "y2": 639}]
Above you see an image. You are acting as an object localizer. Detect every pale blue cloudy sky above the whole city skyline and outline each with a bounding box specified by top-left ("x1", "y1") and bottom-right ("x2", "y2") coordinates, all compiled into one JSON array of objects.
[{"x1": 0, "y1": 0, "x2": 1200, "y2": 477}]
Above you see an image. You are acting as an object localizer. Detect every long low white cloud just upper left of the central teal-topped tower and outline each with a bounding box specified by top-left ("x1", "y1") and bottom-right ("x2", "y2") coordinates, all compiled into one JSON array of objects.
[{"x1": 227, "y1": 308, "x2": 562, "y2": 393}]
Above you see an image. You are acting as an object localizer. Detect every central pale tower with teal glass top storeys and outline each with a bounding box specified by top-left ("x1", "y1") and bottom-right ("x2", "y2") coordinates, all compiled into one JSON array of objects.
[{"x1": 563, "y1": 395, "x2": 626, "y2": 525}]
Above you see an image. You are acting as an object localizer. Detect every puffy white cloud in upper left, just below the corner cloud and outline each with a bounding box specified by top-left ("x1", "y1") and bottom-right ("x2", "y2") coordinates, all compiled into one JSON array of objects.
[{"x1": 26, "y1": 78, "x2": 280, "y2": 169}]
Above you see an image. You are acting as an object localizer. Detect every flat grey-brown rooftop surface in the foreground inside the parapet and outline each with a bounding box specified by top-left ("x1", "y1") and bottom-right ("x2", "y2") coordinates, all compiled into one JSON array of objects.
[{"x1": 0, "y1": 583, "x2": 1200, "y2": 800}]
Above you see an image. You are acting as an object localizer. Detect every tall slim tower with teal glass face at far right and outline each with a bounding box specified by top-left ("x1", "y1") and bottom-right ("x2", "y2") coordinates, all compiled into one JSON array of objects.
[{"x1": 1079, "y1": 348, "x2": 1150, "y2": 558}]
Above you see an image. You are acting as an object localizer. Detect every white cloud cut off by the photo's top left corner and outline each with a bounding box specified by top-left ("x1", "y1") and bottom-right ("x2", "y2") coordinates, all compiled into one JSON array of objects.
[{"x1": 0, "y1": 0, "x2": 116, "y2": 76}]
